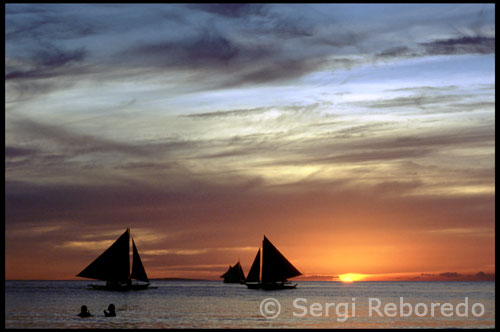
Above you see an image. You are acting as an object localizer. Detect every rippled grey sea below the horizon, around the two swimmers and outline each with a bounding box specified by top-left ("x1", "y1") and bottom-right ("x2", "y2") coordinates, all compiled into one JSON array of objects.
[{"x1": 5, "y1": 281, "x2": 495, "y2": 328}]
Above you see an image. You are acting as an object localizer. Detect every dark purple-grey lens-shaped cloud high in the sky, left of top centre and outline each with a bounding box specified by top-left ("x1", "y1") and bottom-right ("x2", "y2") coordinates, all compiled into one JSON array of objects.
[{"x1": 117, "y1": 30, "x2": 328, "y2": 88}]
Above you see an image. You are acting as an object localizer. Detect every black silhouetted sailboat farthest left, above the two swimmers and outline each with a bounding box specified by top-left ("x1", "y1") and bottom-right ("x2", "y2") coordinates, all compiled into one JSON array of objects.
[{"x1": 76, "y1": 227, "x2": 149, "y2": 291}]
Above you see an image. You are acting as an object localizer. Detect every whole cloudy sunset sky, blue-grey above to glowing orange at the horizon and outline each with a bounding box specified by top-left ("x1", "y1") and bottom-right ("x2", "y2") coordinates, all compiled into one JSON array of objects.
[{"x1": 5, "y1": 4, "x2": 495, "y2": 279}]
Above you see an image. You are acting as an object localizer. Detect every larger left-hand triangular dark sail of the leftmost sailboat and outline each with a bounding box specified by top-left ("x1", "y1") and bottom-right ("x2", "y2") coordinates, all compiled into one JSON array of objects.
[{"x1": 77, "y1": 228, "x2": 130, "y2": 282}]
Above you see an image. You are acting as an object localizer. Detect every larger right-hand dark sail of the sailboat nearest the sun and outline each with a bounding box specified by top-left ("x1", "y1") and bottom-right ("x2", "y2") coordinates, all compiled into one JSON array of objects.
[{"x1": 262, "y1": 236, "x2": 302, "y2": 283}]
